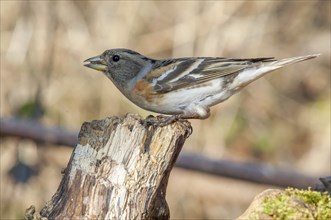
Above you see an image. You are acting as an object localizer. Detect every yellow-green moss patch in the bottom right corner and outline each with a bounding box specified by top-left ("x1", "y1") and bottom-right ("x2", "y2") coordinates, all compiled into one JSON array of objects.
[{"x1": 250, "y1": 188, "x2": 331, "y2": 220}]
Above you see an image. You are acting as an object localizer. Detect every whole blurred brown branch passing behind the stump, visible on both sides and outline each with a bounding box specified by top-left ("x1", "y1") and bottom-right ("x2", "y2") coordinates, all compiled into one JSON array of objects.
[{"x1": 0, "y1": 118, "x2": 319, "y2": 188}]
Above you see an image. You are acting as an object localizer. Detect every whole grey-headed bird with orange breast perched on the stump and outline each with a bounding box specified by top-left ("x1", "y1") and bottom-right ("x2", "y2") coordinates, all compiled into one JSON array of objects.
[{"x1": 84, "y1": 49, "x2": 318, "y2": 122}]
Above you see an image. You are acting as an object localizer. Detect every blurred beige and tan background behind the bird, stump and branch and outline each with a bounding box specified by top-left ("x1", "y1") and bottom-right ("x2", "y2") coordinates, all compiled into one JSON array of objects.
[{"x1": 0, "y1": 1, "x2": 331, "y2": 219}]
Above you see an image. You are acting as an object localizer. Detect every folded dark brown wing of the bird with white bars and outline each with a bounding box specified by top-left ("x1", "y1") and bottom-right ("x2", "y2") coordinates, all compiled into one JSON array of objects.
[{"x1": 144, "y1": 57, "x2": 275, "y2": 93}]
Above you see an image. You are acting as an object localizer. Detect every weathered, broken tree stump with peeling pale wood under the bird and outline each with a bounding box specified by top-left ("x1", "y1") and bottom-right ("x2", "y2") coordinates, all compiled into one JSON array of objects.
[{"x1": 26, "y1": 114, "x2": 192, "y2": 219}]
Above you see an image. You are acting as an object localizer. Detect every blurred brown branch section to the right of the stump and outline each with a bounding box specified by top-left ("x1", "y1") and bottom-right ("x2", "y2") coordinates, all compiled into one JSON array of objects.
[{"x1": 176, "y1": 154, "x2": 318, "y2": 188}]
